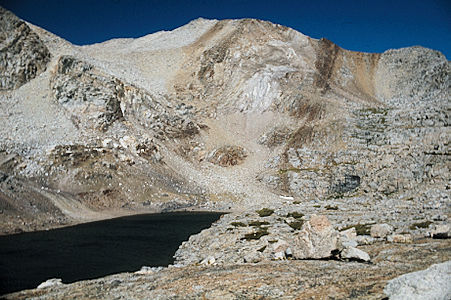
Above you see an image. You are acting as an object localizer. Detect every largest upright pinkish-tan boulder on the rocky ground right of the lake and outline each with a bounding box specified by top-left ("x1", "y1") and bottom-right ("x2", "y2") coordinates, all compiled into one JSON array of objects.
[{"x1": 292, "y1": 215, "x2": 338, "y2": 259}]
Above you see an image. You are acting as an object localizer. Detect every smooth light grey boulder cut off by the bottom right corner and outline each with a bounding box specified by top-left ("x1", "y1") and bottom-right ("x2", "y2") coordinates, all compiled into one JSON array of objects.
[{"x1": 384, "y1": 261, "x2": 451, "y2": 300}]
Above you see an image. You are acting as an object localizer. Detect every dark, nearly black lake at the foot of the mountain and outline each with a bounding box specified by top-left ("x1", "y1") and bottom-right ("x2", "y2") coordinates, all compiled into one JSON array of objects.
[{"x1": 0, "y1": 213, "x2": 221, "y2": 295}]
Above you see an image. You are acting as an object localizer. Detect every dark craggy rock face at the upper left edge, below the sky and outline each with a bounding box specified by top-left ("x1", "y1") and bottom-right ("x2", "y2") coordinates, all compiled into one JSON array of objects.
[{"x1": 0, "y1": 7, "x2": 50, "y2": 90}]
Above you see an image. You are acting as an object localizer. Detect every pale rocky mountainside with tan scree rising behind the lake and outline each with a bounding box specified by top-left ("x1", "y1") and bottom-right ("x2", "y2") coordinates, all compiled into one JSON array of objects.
[{"x1": 0, "y1": 9, "x2": 450, "y2": 232}]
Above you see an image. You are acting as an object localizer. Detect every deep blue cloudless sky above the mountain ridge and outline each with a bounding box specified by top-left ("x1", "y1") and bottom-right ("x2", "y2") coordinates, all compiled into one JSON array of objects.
[{"x1": 0, "y1": 0, "x2": 451, "y2": 59}]
